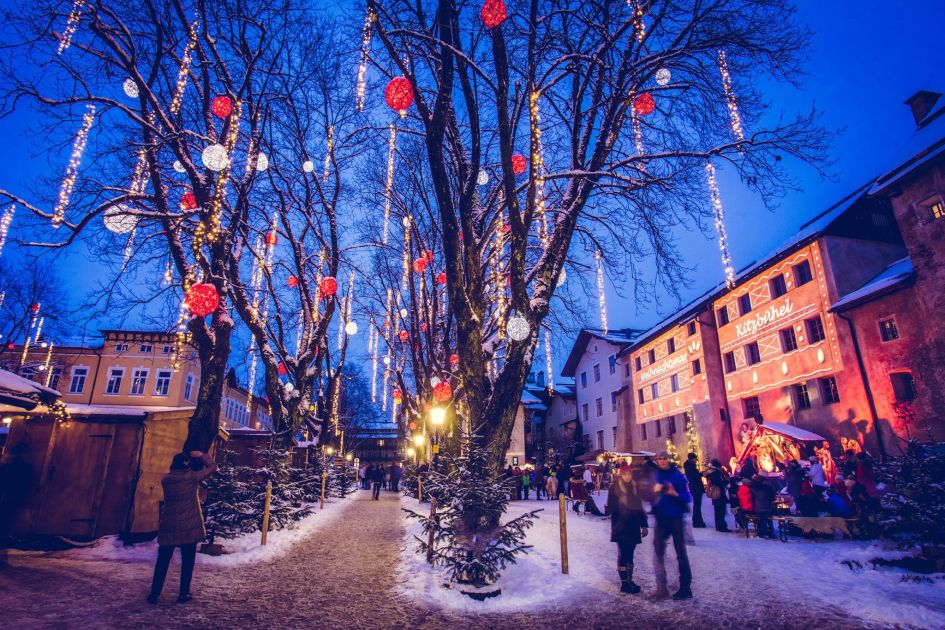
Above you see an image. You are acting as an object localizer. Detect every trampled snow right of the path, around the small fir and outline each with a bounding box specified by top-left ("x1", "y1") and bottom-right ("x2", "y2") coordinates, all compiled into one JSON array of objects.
[{"x1": 397, "y1": 493, "x2": 945, "y2": 628}]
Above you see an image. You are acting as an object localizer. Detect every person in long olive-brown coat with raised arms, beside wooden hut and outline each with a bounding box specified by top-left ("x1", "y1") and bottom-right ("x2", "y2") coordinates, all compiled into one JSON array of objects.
[{"x1": 148, "y1": 451, "x2": 217, "y2": 604}]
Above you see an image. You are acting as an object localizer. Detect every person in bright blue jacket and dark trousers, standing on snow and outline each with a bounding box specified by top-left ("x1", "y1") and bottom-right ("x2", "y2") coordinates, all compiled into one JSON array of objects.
[{"x1": 652, "y1": 451, "x2": 692, "y2": 600}]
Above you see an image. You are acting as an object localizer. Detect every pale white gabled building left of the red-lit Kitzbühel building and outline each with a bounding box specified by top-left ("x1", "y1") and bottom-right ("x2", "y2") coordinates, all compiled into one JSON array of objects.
[{"x1": 561, "y1": 328, "x2": 640, "y2": 452}]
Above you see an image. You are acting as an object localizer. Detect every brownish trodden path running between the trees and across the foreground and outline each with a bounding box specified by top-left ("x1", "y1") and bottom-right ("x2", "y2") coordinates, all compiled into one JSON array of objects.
[{"x1": 0, "y1": 492, "x2": 862, "y2": 630}]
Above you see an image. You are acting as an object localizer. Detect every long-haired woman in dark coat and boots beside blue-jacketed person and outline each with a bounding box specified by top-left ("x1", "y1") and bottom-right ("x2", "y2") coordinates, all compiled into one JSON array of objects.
[{"x1": 605, "y1": 464, "x2": 649, "y2": 594}]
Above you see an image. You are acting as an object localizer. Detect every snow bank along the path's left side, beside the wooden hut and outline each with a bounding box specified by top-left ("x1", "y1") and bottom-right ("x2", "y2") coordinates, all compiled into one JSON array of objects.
[{"x1": 16, "y1": 499, "x2": 360, "y2": 566}]
